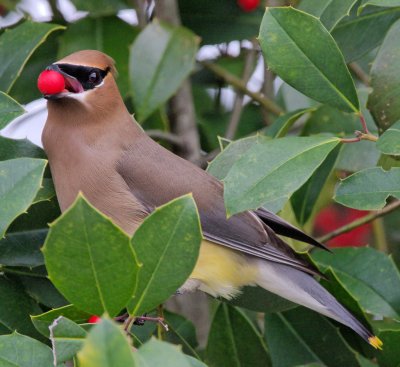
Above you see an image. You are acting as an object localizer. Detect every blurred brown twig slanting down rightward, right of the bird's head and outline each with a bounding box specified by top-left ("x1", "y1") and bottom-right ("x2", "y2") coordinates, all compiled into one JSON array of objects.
[{"x1": 200, "y1": 61, "x2": 283, "y2": 115}]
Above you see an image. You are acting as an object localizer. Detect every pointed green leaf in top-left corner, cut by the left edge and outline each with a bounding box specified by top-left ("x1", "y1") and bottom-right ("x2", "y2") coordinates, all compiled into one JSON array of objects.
[{"x1": 0, "y1": 21, "x2": 64, "y2": 92}]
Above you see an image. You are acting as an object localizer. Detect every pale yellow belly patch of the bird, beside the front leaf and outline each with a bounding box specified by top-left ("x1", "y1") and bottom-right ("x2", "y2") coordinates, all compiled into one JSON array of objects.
[{"x1": 190, "y1": 240, "x2": 258, "y2": 299}]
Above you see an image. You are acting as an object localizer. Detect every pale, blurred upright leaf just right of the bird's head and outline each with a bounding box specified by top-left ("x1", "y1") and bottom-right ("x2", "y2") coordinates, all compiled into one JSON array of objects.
[{"x1": 129, "y1": 21, "x2": 199, "y2": 121}]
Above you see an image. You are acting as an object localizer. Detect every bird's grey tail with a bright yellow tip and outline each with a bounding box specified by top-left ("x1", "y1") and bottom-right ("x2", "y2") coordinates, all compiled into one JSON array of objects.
[{"x1": 257, "y1": 260, "x2": 382, "y2": 349}]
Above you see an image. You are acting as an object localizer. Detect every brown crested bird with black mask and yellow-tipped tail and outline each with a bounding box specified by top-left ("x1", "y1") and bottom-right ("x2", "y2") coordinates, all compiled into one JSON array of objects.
[{"x1": 42, "y1": 50, "x2": 382, "y2": 349}]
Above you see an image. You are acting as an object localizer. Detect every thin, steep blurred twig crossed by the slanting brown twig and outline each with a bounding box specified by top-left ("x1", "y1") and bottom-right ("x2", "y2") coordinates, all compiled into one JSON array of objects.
[{"x1": 225, "y1": 41, "x2": 257, "y2": 139}]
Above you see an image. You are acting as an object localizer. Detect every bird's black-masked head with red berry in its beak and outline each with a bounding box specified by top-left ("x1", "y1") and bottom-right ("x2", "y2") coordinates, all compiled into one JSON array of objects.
[{"x1": 38, "y1": 50, "x2": 116, "y2": 101}]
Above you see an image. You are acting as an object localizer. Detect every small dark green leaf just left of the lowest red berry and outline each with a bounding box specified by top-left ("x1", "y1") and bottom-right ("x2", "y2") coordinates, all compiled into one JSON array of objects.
[{"x1": 31, "y1": 305, "x2": 91, "y2": 338}]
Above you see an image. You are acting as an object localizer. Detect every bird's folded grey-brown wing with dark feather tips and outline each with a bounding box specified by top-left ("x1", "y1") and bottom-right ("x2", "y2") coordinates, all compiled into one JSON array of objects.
[{"x1": 117, "y1": 136, "x2": 321, "y2": 275}]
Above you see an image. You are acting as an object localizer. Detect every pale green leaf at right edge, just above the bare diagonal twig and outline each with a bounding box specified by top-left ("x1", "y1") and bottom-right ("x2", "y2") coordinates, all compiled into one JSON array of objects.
[{"x1": 334, "y1": 167, "x2": 400, "y2": 210}]
